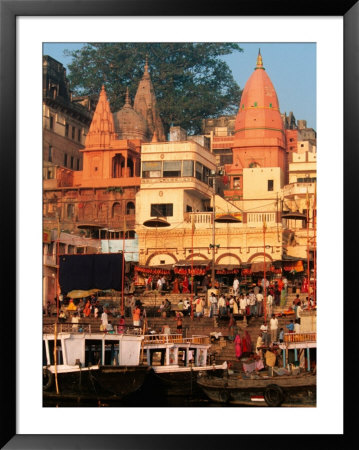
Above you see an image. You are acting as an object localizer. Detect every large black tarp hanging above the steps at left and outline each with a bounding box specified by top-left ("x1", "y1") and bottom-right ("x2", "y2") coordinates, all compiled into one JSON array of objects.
[{"x1": 59, "y1": 253, "x2": 122, "y2": 295}]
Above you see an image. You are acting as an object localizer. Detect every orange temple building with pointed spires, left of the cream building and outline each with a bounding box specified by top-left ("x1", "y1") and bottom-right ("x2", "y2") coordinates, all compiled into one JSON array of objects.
[{"x1": 43, "y1": 59, "x2": 163, "y2": 298}]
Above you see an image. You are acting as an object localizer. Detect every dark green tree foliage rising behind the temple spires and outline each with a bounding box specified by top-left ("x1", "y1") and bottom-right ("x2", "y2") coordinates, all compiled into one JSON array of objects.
[{"x1": 67, "y1": 42, "x2": 242, "y2": 134}]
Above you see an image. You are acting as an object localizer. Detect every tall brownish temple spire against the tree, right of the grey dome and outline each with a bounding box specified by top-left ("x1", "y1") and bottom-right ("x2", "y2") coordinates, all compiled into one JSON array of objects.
[{"x1": 133, "y1": 60, "x2": 166, "y2": 142}]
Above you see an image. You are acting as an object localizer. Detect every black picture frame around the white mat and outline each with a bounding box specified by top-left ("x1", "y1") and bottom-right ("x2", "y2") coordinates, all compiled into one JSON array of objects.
[{"x1": 0, "y1": 0, "x2": 359, "y2": 450}]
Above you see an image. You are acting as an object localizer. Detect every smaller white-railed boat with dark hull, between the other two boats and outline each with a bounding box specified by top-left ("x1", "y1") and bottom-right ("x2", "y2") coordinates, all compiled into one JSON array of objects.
[{"x1": 143, "y1": 334, "x2": 228, "y2": 396}]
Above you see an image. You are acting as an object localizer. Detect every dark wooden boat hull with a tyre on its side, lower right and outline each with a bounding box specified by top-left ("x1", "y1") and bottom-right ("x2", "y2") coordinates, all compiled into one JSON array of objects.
[{"x1": 197, "y1": 374, "x2": 316, "y2": 407}]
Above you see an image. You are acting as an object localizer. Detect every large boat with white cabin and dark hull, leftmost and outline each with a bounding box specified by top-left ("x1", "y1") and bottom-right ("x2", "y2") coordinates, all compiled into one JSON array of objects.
[{"x1": 43, "y1": 324, "x2": 150, "y2": 400}]
